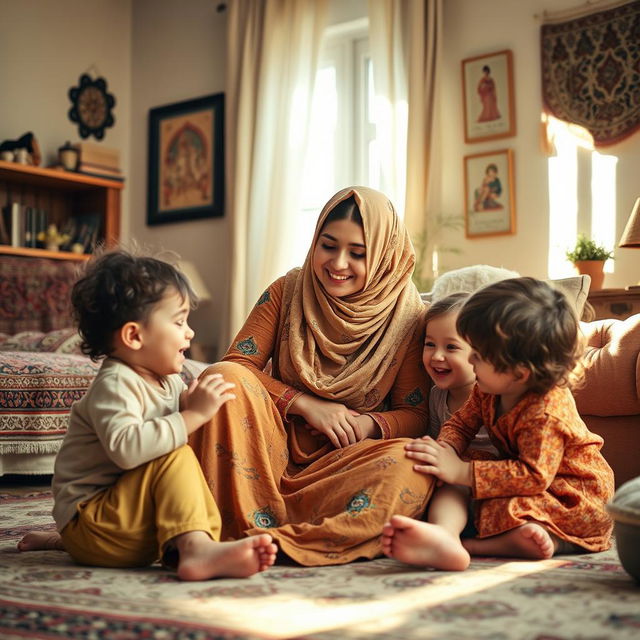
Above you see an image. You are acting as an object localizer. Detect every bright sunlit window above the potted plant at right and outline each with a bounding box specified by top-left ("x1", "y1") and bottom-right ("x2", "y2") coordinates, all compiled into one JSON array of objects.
[{"x1": 545, "y1": 116, "x2": 618, "y2": 278}]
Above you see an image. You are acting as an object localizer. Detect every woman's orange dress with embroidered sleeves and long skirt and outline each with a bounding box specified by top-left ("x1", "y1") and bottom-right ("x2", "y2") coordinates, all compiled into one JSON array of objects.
[{"x1": 189, "y1": 277, "x2": 434, "y2": 566}]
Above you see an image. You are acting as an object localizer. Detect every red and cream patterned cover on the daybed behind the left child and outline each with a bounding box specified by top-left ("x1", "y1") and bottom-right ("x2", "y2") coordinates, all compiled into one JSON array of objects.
[{"x1": 0, "y1": 351, "x2": 100, "y2": 454}]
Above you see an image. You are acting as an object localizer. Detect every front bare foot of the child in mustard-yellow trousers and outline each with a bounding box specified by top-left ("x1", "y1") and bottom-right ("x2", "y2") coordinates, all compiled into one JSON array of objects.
[{"x1": 175, "y1": 531, "x2": 278, "y2": 580}]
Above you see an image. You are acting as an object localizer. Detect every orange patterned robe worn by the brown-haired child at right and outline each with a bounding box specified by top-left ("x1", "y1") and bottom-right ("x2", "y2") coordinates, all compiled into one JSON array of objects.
[{"x1": 438, "y1": 385, "x2": 614, "y2": 551}]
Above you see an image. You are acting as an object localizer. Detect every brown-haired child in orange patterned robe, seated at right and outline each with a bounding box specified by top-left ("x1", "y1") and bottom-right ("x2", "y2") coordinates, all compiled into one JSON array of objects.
[{"x1": 382, "y1": 278, "x2": 614, "y2": 571}]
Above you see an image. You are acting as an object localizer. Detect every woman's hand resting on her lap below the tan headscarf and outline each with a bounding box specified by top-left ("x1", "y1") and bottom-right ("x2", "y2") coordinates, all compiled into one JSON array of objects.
[{"x1": 289, "y1": 393, "x2": 373, "y2": 449}]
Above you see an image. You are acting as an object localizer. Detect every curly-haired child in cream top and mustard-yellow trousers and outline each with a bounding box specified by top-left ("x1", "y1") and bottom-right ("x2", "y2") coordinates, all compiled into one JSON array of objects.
[{"x1": 21, "y1": 251, "x2": 277, "y2": 580}]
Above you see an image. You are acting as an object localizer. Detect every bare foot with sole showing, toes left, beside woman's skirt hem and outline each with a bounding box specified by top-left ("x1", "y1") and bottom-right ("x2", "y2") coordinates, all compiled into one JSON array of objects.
[{"x1": 382, "y1": 515, "x2": 470, "y2": 571}]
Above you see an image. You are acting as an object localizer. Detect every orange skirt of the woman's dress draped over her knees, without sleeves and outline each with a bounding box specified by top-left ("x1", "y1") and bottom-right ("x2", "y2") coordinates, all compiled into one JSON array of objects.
[{"x1": 189, "y1": 360, "x2": 434, "y2": 566}]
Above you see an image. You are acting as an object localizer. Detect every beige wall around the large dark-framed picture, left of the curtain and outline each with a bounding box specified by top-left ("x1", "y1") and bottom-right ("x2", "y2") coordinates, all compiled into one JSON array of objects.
[{"x1": 129, "y1": 0, "x2": 230, "y2": 359}]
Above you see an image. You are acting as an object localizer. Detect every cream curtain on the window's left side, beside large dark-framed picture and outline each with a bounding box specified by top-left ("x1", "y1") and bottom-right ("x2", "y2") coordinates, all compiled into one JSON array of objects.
[{"x1": 222, "y1": 0, "x2": 327, "y2": 348}]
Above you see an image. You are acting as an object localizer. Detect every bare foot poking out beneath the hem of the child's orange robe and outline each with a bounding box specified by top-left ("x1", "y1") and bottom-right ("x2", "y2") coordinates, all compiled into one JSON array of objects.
[{"x1": 463, "y1": 522, "x2": 559, "y2": 560}]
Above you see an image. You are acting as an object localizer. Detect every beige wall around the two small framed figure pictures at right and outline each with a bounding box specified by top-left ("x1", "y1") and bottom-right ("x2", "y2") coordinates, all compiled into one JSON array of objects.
[{"x1": 436, "y1": 0, "x2": 640, "y2": 287}]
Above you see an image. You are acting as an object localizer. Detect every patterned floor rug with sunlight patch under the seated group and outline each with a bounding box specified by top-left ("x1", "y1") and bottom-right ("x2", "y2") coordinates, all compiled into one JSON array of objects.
[{"x1": 0, "y1": 492, "x2": 640, "y2": 640}]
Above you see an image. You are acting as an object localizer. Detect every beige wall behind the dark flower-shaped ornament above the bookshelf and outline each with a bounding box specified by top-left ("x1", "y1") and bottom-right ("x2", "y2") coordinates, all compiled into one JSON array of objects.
[{"x1": 0, "y1": 0, "x2": 131, "y2": 232}]
